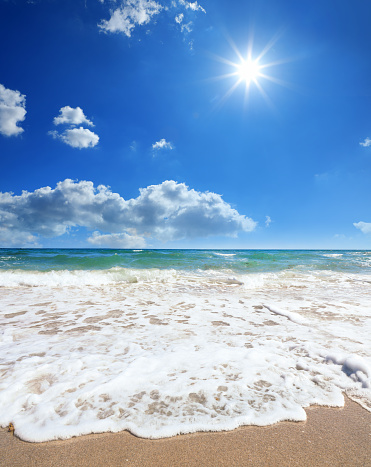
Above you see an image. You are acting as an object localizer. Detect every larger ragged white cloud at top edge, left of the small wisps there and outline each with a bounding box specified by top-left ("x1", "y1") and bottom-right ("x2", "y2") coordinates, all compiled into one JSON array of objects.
[{"x1": 98, "y1": 0, "x2": 163, "y2": 37}]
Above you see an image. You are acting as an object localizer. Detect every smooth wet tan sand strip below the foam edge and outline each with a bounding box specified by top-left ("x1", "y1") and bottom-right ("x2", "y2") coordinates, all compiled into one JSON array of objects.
[{"x1": 0, "y1": 399, "x2": 371, "y2": 467}]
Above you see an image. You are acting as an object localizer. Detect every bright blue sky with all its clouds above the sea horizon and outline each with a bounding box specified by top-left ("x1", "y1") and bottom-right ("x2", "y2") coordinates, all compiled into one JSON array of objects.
[{"x1": 0, "y1": 0, "x2": 371, "y2": 249}]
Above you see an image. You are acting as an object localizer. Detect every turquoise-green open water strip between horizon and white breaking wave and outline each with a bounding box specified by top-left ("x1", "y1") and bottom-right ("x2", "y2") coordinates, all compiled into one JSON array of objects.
[{"x1": 0, "y1": 249, "x2": 371, "y2": 274}]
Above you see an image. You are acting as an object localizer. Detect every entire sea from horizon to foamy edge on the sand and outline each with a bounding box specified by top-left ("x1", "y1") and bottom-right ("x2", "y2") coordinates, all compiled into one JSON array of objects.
[{"x1": 0, "y1": 249, "x2": 371, "y2": 442}]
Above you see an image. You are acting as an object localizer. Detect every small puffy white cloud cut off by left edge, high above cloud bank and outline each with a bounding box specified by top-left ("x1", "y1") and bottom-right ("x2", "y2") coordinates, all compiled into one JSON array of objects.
[{"x1": 0, "y1": 84, "x2": 27, "y2": 136}]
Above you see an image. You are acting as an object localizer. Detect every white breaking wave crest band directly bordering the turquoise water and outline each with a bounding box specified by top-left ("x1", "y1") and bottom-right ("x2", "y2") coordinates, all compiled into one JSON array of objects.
[{"x1": 0, "y1": 267, "x2": 370, "y2": 290}]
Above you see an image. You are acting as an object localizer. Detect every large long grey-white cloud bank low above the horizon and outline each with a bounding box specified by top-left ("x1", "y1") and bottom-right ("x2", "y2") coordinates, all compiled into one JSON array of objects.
[{"x1": 0, "y1": 179, "x2": 256, "y2": 246}]
